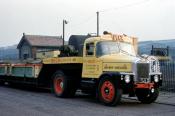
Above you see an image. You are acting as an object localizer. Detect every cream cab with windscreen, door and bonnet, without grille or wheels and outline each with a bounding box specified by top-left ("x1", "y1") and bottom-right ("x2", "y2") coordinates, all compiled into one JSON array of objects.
[{"x1": 82, "y1": 35, "x2": 137, "y2": 78}]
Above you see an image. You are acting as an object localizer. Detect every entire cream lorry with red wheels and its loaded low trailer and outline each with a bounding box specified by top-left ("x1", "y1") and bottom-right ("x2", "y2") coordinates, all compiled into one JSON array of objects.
[{"x1": 0, "y1": 33, "x2": 162, "y2": 106}]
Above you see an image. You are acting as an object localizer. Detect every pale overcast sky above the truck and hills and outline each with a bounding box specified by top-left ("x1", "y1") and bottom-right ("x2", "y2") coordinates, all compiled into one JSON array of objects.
[{"x1": 0, "y1": 0, "x2": 175, "y2": 47}]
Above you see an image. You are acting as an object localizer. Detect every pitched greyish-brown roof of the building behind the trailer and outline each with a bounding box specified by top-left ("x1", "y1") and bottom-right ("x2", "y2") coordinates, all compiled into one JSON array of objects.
[{"x1": 17, "y1": 34, "x2": 63, "y2": 48}]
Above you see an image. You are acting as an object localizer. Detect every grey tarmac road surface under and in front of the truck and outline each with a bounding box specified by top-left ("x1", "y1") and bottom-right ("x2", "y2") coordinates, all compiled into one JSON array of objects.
[{"x1": 0, "y1": 86, "x2": 175, "y2": 116}]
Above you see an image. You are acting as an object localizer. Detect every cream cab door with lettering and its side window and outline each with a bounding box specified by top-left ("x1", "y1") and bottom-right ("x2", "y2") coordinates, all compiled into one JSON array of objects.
[{"x1": 82, "y1": 42, "x2": 102, "y2": 78}]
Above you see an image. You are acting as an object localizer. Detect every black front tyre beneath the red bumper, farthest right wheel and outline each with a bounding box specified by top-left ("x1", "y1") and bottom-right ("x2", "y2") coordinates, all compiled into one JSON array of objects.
[{"x1": 136, "y1": 88, "x2": 159, "y2": 104}]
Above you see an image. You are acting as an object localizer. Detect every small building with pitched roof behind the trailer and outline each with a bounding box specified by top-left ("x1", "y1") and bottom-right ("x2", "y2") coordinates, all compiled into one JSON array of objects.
[{"x1": 17, "y1": 33, "x2": 63, "y2": 59}]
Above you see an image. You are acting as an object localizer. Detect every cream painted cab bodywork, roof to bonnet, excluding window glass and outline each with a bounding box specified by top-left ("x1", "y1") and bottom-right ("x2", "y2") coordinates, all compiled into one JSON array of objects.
[{"x1": 82, "y1": 35, "x2": 136, "y2": 78}]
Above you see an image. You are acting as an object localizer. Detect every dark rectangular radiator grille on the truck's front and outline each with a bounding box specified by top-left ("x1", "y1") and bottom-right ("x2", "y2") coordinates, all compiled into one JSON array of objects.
[{"x1": 137, "y1": 63, "x2": 149, "y2": 78}]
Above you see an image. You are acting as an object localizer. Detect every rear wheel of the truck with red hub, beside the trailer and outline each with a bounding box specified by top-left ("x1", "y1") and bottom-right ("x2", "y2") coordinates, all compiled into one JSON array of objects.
[{"x1": 52, "y1": 71, "x2": 76, "y2": 98}]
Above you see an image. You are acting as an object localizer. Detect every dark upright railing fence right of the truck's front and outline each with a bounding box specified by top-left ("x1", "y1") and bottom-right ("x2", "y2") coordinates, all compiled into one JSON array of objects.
[{"x1": 160, "y1": 61, "x2": 175, "y2": 93}]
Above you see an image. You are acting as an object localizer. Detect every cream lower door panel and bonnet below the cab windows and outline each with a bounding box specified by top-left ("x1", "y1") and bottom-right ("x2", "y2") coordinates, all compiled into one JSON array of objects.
[{"x1": 82, "y1": 53, "x2": 135, "y2": 78}]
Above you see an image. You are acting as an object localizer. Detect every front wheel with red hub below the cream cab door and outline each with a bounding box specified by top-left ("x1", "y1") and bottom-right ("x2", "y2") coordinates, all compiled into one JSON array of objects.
[{"x1": 98, "y1": 77, "x2": 122, "y2": 106}]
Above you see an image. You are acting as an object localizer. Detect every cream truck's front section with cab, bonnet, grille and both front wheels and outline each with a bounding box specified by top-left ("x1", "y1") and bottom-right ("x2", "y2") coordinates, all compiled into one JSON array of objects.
[{"x1": 82, "y1": 34, "x2": 162, "y2": 105}]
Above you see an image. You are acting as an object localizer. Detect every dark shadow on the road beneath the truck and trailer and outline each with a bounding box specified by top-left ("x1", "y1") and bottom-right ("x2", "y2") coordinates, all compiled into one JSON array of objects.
[{"x1": 0, "y1": 84, "x2": 146, "y2": 107}]
